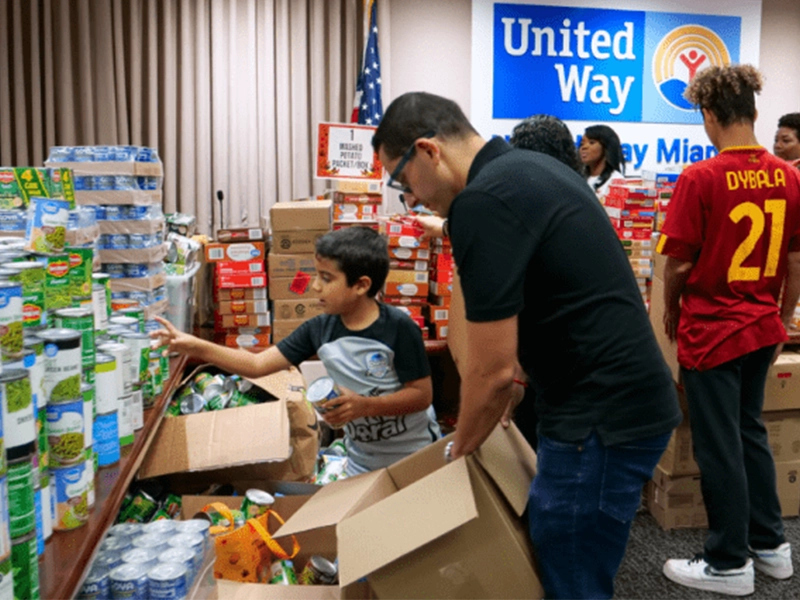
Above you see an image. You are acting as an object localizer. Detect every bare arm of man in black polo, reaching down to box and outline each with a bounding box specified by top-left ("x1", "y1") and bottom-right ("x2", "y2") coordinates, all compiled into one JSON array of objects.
[{"x1": 450, "y1": 316, "x2": 518, "y2": 458}]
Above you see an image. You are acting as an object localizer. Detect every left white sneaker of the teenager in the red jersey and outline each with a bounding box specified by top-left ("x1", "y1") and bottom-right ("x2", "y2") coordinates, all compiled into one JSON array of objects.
[{"x1": 664, "y1": 555, "x2": 756, "y2": 596}]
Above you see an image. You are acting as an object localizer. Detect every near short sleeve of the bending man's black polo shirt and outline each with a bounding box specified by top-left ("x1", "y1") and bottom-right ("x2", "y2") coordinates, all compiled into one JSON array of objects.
[{"x1": 450, "y1": 192, "x2": 536, "y2": 322}]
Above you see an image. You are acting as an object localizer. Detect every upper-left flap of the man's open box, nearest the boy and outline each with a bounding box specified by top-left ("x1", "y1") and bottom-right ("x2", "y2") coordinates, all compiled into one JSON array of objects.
[{"x1": 274, "y1": 470, "x2": 395, "y2": 537}]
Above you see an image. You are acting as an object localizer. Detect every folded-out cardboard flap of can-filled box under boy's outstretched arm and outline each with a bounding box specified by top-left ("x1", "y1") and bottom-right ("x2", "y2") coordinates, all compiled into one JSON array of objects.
[{"x1": 139, "y1": 399, "x2": 291, "y2": 479}]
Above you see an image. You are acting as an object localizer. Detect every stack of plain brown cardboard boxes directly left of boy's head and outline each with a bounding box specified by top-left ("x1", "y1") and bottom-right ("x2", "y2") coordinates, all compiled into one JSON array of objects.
[{"x1": 269, "y1": 200, "x2": 333, "y2": 344}]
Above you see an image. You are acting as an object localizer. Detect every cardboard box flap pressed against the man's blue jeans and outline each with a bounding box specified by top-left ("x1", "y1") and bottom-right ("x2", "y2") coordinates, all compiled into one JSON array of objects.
[{"x1": 475, "y1": 423, "x2": 536, "y2": 516}]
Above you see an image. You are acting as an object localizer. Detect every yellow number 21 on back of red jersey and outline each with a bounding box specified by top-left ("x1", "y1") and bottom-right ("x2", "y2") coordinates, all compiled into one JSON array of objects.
[{"x1": 728, "y1": 200, "x2": 786, "y2": 283}]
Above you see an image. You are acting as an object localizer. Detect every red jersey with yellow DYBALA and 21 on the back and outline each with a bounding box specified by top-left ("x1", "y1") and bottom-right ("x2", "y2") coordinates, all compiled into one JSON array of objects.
[{"x1": 657, "y1": 146, "x2": 800, "y2": 371}]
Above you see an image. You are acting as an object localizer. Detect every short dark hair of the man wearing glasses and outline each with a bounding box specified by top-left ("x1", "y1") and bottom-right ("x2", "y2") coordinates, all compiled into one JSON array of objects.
[{"x1": 372, "y1": 92, "x2": 478, "y2": 158}]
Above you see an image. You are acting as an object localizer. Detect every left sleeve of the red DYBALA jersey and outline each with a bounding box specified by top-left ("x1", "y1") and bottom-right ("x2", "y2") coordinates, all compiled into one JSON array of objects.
[{"x1": 656, "y1": 172, "x2": 705, "y2": 262}]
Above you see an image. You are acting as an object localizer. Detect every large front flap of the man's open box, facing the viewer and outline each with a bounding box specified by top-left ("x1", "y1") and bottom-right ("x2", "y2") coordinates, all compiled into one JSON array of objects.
[{"x1": 336, "y1": 458, "x2": 478, "y2": 586}]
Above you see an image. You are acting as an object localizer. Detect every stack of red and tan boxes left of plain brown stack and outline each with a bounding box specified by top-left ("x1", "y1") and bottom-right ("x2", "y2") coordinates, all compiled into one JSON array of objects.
[{"x1": 205, "y1": 228, "x2": 269, "y2": 348}]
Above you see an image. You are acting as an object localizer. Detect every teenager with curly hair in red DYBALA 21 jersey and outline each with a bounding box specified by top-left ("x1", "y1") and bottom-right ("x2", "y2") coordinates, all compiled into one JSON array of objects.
[{"x1": 658, "y1": 65, "x2": 800, "y2": 596}]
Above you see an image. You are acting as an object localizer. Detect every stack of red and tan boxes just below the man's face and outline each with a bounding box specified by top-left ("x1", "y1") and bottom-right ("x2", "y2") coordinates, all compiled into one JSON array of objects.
[{"x1": 379, "y1": 219, "x2": 431, "y2": 339}]
